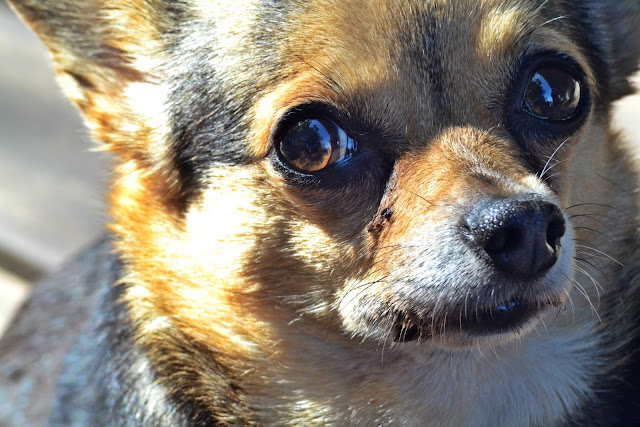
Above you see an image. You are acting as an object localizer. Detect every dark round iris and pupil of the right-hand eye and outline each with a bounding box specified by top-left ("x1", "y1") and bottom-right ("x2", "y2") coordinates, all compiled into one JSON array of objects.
[{"x1": 523, "y1": 68, "x2": 580, "y2": 120}]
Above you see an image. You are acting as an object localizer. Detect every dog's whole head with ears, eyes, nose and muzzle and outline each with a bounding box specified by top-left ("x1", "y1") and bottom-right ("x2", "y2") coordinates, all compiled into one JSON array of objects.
[{"x1": 8, "y1": 0, "x2": 640, "y2": 353}]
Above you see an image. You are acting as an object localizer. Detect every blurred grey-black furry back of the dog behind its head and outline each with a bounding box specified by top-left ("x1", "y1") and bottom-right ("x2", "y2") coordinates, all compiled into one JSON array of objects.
[{"x1": 0, "y1": 238, "x2": 187, "y2": 426}]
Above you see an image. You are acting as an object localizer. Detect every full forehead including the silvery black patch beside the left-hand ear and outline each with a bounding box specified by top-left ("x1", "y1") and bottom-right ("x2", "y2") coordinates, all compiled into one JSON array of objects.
[{"x1": 170, "y1": 0, "x2": 590, "y2": 167}]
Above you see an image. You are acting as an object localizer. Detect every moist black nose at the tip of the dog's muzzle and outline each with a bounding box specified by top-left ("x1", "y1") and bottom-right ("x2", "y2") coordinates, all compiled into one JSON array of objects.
[{"x1": 467, "y1": 196, "x2": 565, "y2": 278}]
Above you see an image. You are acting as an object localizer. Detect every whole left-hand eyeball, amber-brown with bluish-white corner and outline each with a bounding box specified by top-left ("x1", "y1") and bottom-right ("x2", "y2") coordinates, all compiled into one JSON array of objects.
[{"x1": 279, "y1": 119, "x2": 356, "y2": 173}]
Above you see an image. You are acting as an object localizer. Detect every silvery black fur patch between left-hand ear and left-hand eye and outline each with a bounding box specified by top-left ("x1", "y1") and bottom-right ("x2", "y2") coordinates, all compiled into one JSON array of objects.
[{"x1": 169, "y1": 1, "x2": 293, "y2": 206}]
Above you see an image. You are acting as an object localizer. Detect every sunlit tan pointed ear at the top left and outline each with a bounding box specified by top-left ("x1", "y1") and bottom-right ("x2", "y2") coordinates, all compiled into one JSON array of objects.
[{"x1": 9, "y1": 0, "x2": 170, "y2": 159}]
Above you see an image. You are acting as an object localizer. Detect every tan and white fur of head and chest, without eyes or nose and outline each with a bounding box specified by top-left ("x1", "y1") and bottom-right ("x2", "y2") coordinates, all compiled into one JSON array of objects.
[{"x1": 5, "y1": 0, "x2": 640, "y2": 426}]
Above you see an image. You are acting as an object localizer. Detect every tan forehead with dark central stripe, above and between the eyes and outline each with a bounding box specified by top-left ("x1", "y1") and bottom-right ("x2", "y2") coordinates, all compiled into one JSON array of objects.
[{"x1": 231, "y1": 0, "x2": 592, "y2": 144}]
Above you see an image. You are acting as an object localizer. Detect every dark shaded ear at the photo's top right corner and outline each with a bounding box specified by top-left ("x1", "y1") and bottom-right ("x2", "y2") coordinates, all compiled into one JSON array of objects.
[{"x1": 592, "y1": 0, "x2": 640, "y2": 100}]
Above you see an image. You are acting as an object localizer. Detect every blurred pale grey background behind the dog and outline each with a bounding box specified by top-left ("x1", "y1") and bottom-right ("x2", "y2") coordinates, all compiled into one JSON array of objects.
[{"x1": 0, "y1": 0, "x2": 640, "y2": 335}]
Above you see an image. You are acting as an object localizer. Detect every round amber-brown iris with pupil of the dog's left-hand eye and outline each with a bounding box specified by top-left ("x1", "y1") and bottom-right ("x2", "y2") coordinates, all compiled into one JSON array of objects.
[{"x1": 280, "y1": 119, "x2": 337, "y2": 172}]
